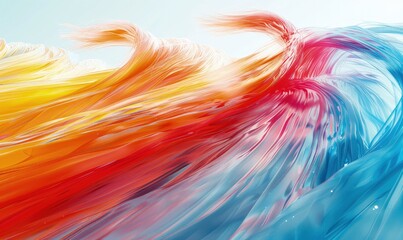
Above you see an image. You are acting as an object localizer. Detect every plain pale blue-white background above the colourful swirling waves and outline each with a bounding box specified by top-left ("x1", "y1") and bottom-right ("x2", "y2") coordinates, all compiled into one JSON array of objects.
[{"x1": 0, "y1": 0, "x2": 403, "y2": 65}]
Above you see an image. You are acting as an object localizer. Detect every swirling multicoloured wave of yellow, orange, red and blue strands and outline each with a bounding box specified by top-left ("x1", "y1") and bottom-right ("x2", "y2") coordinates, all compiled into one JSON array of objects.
[{"x1": 0, "y1": 13, "x2": 403, "y2": 239}]
